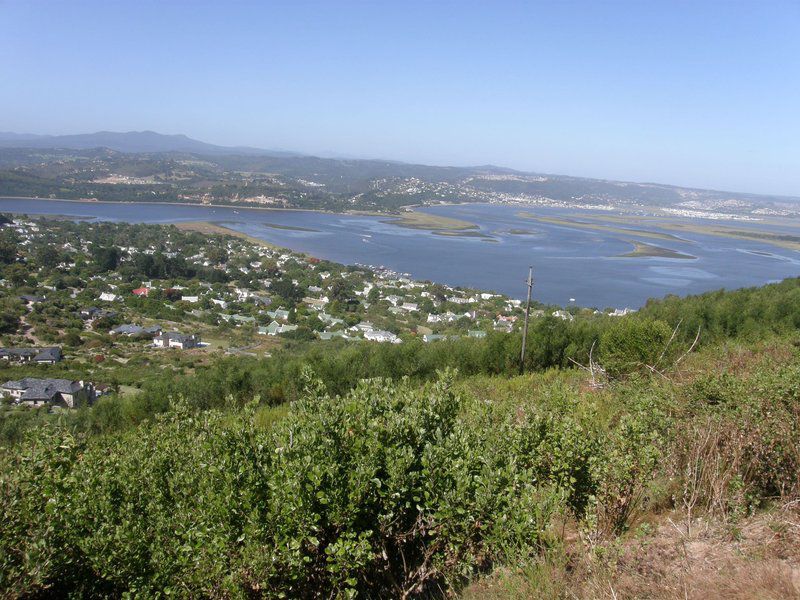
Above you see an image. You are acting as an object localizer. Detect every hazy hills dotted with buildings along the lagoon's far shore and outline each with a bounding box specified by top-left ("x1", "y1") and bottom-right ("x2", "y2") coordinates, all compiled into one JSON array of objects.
[{"x1": 0, "y1": 131, "x2": 800, "y2": 216}]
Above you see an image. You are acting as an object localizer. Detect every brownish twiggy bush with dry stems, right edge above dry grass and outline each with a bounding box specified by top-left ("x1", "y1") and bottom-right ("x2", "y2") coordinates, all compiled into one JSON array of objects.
[{"x1": 670, "y1": 357, "x2": 800, "y2": 517}]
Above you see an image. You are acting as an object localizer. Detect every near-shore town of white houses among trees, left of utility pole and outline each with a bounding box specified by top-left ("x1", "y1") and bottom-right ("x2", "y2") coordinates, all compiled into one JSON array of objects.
[{"x1": 0, "y1": 217, "x2": 625, "y2": 408}]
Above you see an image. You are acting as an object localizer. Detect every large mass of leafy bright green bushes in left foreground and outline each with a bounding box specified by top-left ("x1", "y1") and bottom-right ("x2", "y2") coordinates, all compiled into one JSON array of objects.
[{"x1": 0, "y1": 376, "x2": 668, "y2": 597}]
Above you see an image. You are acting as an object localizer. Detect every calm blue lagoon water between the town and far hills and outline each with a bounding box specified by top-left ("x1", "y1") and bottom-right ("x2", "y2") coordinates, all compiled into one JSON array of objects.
[{"x1": 0, "y1": 198, "x2": 800, "y2": 308}]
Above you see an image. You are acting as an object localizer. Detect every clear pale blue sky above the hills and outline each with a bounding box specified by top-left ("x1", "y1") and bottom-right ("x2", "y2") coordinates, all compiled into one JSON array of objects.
[{"x1": 0, "y1": 0, "x2": 800, "y2": 196}]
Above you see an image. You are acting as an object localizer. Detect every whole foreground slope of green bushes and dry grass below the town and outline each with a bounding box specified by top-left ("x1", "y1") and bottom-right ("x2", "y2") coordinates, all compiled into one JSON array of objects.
[{"x1": 0, "y1": 280, "x2": 800, "y2": 597}]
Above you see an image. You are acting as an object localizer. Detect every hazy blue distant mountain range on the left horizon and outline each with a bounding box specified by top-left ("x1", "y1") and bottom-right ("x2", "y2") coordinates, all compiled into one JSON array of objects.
[{"x1": 0, "y1": 131, "x2": 299, "y2": 156}]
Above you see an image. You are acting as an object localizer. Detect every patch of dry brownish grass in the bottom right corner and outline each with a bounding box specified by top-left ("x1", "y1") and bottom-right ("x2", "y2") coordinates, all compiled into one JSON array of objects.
[{"x1": 462, "y1": 508, "x2": 800, "y2": 600}]
